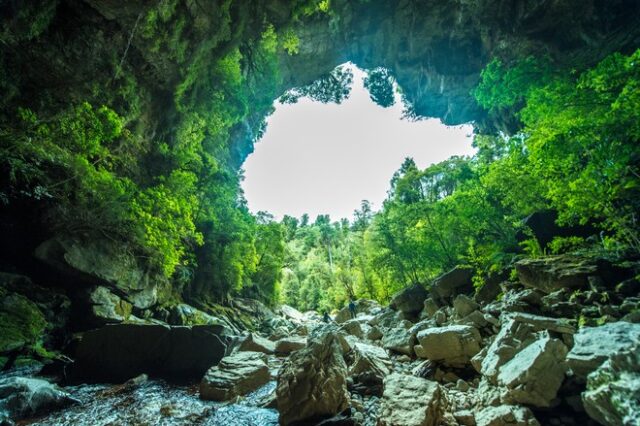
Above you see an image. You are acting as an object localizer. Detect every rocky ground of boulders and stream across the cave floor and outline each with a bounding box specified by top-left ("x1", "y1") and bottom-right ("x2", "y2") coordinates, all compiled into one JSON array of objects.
[{"x1": 0, "y1": 256, "x2": 640, "y2": 426}]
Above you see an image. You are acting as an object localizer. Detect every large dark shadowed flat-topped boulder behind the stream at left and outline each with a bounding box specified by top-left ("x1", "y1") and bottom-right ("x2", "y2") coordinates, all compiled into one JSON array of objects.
[{"x1": 71, "y1": 324, "x2": 233, "y2": 383}]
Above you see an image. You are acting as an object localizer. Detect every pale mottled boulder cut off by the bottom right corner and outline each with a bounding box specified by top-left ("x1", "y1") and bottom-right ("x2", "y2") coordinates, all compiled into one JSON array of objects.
[{"x1": 582, "y1": 346, "x2": 640, "y2": 426}]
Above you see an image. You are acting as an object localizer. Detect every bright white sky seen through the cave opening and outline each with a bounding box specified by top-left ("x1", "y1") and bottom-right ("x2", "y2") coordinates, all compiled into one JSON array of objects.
[{"x1": 242, "y1": 67, "x2": 474, "y2": 221}]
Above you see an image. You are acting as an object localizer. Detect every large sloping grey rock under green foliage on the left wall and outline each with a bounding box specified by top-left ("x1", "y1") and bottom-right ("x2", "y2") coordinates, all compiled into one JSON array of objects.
[{"x1": 35, "y1": 234, "x2": 170, "y2": 309}]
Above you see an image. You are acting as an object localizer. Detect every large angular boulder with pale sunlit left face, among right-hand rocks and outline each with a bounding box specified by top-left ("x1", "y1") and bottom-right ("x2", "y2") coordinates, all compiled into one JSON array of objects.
[{"x1": 498, "y1": 332, "x2": 568, "y2": 407}]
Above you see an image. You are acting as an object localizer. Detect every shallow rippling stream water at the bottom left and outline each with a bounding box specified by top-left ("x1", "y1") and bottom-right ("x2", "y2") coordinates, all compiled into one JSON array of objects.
[{"x1": 22, "y1": 380, "x2": 278, "y2": 426}]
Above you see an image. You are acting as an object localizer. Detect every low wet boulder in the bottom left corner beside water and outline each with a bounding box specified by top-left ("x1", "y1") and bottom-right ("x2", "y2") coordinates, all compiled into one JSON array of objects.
[{"x1": 0, "y1": 377, "x2": 79, "y2": 421}]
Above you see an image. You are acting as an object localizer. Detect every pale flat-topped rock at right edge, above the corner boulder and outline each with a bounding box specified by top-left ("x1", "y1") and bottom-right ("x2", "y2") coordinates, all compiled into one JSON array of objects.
[{"x1": 567, "y1": 321, "x2": 640, "y2": 380}]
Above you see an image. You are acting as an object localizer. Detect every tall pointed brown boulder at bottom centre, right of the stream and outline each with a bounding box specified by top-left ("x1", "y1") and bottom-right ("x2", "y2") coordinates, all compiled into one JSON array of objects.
[{"x1": 276, "y1": 326, "x2": 350, "y2": 425}]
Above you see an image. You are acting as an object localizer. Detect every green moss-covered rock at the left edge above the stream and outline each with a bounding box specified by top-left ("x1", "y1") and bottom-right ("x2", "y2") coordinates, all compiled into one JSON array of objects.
[{"x1": 0, "y1": 294, "x2": 47, "y2": 353}]
